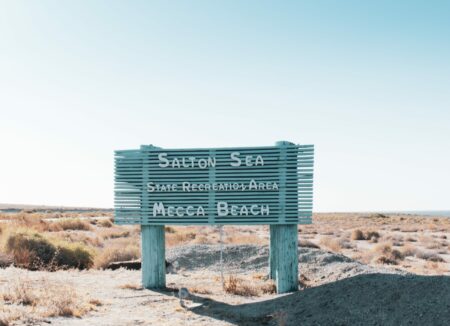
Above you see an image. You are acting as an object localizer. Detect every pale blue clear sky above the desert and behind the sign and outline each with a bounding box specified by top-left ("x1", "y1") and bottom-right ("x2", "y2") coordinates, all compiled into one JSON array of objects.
[{"x1": 0, "y1": 0, "x2": 450, "y2": 211}]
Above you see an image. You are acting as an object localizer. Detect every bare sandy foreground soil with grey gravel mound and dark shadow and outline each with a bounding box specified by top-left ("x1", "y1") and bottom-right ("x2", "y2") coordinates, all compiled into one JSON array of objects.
[{"x1": 0, "y1": 245, "x2": 450, "y2": 326}]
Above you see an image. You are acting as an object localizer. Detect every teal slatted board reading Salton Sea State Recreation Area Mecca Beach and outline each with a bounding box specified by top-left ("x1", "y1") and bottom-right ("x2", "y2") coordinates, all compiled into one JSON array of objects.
[{"x1": 115, "y1": 142, "x2": 314, "y2": 225}]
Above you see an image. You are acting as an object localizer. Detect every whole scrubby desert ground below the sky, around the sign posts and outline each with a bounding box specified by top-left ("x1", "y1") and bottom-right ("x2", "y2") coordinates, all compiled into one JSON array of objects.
[{"x1": 0, "y1": 209, "x2": 450, "y2": 326}]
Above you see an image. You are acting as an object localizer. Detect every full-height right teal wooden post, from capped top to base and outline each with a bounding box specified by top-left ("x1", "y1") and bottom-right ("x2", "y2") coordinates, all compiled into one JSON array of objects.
[{"x1": 269, "y1": 141, "x2": 298, "y2": 293}]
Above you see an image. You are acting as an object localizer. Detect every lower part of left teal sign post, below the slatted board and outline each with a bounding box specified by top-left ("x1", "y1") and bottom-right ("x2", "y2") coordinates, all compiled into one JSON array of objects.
[{"x1": 141, "y1": 225, "x2": 166, "y2": 289}]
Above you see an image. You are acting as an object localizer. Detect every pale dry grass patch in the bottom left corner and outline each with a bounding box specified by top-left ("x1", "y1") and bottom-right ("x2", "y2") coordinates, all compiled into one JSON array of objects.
[{"x1": 0, "y1": 278, "x2": 96, "y2": 325}]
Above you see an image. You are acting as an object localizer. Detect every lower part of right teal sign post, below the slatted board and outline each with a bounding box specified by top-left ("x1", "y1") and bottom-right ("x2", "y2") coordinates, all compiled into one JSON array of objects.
[{"x1": 270, "y1": 224, "x2": 298, "y2": 294}]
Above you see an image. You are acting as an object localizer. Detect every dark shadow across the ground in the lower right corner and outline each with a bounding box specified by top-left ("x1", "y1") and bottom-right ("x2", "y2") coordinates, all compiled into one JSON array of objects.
[{"x1": 170, "y1": 274, "x2": 450, "y2": 326}]
